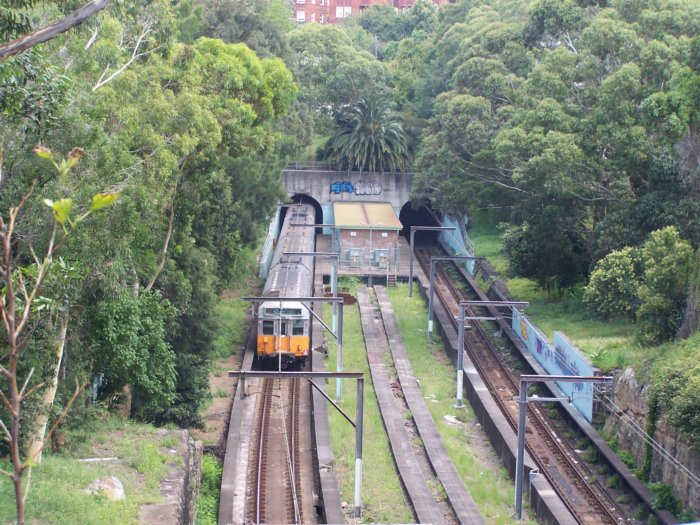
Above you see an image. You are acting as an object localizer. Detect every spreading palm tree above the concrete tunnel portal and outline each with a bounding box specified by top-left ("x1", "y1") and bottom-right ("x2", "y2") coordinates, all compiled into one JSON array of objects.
[{"x1": 326, "y1": 97, "x2": 409, "y2": 173}]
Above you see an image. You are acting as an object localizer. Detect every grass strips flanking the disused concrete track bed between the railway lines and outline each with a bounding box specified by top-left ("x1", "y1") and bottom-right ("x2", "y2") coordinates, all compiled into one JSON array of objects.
[{"x1": 326, "y1": 282, "x2": 540, "y2": 525}]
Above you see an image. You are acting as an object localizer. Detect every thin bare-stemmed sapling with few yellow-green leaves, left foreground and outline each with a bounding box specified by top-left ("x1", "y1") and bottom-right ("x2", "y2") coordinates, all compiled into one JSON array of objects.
[{"x1": 0, "y1": 148, "x2": 119, "y2": 525}]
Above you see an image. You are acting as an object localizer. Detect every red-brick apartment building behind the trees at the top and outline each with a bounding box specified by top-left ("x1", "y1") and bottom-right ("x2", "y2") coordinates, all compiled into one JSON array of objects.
[{"x1": 294, "y1": 0, "x2": 449, "y2": 25}]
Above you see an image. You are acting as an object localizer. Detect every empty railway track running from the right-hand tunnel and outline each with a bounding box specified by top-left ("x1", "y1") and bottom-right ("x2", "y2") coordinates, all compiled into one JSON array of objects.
[{"x1": 417, "y1": 249, "x2": 626, "y2": 525}]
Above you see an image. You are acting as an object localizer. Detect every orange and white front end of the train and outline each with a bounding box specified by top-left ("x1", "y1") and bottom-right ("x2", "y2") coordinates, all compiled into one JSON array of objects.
[{"x1": 257, "y1": 301, "x2": 311, "y2": 368}]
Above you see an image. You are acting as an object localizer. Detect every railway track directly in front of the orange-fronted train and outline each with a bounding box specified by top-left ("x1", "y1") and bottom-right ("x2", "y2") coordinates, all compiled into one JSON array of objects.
[{"x1": 245, "y1": 379, "x2": 304, "y2": 523}]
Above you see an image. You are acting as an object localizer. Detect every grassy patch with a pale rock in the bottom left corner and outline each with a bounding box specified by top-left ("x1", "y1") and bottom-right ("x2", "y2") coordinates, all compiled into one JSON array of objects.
[{"x1": 0, "y1": 416, "x2": 173, "y2": 525}]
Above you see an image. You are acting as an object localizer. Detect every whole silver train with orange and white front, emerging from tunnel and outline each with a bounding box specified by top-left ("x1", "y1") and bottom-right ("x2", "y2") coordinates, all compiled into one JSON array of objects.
[{"x1": 256, "y1": 204, "x2": 316, "y2": 369}]
